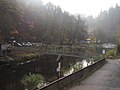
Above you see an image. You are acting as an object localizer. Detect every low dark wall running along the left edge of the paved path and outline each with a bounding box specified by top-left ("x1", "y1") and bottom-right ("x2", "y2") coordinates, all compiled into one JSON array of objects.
[{"x1": 37, "y1": 59, "x2": 106, "y2": 90}]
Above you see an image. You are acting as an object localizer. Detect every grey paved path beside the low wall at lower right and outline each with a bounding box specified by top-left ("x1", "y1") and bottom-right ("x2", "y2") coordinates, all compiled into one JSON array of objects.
[{"x1": 70, "y1": 59, "x2": 120, "y2": 90}]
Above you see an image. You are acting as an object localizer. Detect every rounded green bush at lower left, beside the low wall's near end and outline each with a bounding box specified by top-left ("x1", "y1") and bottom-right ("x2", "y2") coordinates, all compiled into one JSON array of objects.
[{"x1": 21, "y1": 73, "x2": 45, "y2": 90}]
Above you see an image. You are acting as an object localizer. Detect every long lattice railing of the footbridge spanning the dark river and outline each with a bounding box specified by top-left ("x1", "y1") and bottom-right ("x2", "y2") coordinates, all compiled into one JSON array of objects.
[{"x1": 11, "y1": 45, "x2": 83, "y2": 56}]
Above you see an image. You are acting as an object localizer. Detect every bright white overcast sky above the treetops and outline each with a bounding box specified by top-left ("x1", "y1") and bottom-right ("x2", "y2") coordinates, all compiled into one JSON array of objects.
[{"x1": 43, "y1": 0, "x2": 120, "y2": 17}]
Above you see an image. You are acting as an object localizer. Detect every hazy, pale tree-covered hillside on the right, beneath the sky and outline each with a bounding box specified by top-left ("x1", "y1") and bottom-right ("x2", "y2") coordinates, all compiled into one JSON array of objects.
[{"x1": 87, "y1": 4, "x2": 120, "y2": 43}]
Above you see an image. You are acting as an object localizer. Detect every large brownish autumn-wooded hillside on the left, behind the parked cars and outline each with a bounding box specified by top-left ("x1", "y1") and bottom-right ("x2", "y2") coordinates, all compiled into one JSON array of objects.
[{"x1": 0, "y1": 0, "x2": 87, "y2": 43}]
